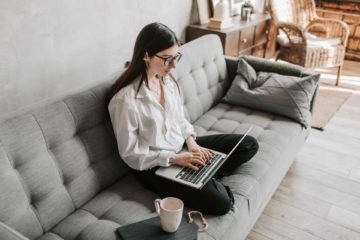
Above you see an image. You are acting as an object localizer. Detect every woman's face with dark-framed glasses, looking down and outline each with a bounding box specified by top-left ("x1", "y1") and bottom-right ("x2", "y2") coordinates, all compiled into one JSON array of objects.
[{"x1": 145, "y1": 44, "x2": 181, "y2": 77}]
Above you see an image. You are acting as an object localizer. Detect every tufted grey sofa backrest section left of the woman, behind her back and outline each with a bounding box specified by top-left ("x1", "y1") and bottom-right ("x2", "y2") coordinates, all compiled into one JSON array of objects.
[{"x1": 0, "y1": 80, "x2": 128, "y2": 239}]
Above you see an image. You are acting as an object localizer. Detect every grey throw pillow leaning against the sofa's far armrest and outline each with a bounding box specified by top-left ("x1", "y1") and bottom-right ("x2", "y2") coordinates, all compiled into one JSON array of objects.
[{"x1": 223, "y1": 58, "x2": 320, "y2": 128}]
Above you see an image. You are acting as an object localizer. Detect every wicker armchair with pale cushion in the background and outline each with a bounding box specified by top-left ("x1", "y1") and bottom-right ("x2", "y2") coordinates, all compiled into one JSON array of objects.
[{"x1": 268, "y1": 0, "x2": 349, "y2": 85}]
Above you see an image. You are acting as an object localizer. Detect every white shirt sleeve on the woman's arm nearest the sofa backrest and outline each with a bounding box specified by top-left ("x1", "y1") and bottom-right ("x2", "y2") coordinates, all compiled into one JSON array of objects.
[{"x1": 109, "y1": 99, "x2": 175, "y2": 171}]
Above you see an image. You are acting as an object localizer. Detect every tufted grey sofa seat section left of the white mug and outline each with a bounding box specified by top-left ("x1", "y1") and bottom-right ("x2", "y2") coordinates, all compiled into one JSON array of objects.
[{"x1": 41, "y1": 174, "x2": 157, "y2": 240}]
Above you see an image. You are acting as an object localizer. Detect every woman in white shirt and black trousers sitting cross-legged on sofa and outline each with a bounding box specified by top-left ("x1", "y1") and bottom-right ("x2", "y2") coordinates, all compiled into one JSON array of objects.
[{"x1": 108, "y1": 23, "x2": 258, "y2": 215}]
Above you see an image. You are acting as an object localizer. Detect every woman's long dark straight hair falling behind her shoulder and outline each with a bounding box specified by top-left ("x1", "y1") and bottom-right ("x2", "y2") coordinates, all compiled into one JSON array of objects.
[{"x1": 106, "y1": 22, "x2": 179, "y2": 105}]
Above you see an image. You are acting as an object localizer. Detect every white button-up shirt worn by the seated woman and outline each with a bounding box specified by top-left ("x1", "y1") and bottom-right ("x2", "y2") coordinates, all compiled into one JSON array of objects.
[{"x1": 108, "y1": 77, "x2": 195, "y2": 170}]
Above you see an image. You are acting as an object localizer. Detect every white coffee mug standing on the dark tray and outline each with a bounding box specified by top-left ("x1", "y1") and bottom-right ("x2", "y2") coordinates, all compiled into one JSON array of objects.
[{"x1": 154, "y1": 197, "x2": 184, "y2": 232}]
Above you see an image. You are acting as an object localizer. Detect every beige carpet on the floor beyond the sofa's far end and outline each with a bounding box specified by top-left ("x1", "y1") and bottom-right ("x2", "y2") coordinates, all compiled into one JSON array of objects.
[{"x1": 311, "y1": 86, "x2": 351, "y2": 130}]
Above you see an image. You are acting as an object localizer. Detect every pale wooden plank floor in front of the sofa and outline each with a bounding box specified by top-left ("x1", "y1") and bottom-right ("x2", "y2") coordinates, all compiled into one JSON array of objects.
[{"x1": 247, "y1": 62, "x2": 360, "y2": 240}]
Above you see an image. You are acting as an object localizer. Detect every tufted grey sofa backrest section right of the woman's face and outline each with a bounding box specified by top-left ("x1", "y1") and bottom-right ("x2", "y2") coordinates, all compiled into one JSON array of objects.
[{"x1": 174, "y1": 34, "x2": 230, "y2": 122}]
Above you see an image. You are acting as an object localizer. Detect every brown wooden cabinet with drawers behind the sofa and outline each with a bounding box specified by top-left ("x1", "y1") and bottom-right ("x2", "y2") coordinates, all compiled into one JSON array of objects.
[{"x1": 186, "y1": 14, "x2": 275, "y2": 57}]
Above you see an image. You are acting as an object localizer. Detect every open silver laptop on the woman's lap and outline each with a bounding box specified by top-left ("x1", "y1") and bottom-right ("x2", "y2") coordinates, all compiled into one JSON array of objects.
[{"x1": 155, "y1": 126, "x2": 253, "y2": 189}]
